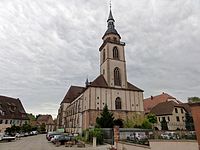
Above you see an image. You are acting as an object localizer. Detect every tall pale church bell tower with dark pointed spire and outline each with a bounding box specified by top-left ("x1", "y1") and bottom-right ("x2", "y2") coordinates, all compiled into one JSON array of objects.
[{"x1": 99, "y1": 7, "x2": 127, "y2": 88}]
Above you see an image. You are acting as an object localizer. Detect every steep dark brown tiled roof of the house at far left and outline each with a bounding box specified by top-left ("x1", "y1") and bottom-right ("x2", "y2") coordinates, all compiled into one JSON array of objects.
[{"x1": 0, "y1": 96, "x2": 29, "y2": 120}]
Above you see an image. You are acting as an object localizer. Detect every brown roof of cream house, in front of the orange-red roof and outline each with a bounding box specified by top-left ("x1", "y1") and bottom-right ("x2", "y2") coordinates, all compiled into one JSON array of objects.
[{"x1": 150, "y1": 101, "x2": 187, "y2": 116}]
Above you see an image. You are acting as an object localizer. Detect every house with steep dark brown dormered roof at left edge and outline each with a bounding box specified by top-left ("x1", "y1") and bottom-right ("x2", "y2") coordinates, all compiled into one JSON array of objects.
[{"x1": 0, "y1": 96, "x2": 29, "y2": 132}]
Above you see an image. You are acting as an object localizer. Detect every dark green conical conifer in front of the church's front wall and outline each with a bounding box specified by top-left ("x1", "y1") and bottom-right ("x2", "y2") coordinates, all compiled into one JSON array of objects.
[{"x1": 96, "y1": 104, "x2": 114, "y2": 128}]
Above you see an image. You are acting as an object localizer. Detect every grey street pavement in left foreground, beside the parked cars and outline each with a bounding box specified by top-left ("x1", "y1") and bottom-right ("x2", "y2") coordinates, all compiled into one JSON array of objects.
[{"x1": 0, "y1": 134, "x2": 109, "y2": 150}]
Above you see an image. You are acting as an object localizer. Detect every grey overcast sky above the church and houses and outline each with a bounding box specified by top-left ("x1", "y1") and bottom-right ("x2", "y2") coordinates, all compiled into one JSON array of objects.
[{"x1": 0, "y1": 0, "x2": 200, "y2": 117}]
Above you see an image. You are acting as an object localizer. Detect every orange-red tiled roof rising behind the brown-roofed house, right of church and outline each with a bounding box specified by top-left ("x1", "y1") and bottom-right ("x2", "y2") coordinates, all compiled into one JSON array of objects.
[{"x1": 144, "y1": 92, "x2": 178, "y2": 113}]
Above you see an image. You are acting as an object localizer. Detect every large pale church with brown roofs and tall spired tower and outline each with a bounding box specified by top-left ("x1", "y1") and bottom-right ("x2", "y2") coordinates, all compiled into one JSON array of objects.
[{"x1": 57, "y1": 7, "x2": 144, "y2": 133}]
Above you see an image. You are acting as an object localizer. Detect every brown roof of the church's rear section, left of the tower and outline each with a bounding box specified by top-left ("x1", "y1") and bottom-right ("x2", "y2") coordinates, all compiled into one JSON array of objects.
[{"x1": 61, "y1": 86, "x2": 85, "y2": 104}]
